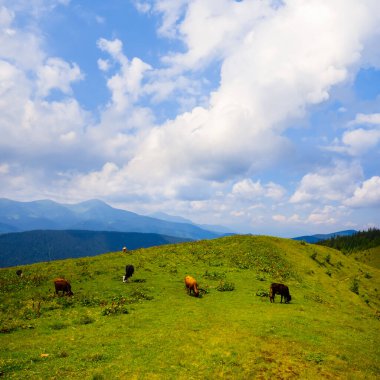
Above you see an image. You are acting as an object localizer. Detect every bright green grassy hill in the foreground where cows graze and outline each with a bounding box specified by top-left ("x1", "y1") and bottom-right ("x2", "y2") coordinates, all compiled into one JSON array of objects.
[{"x1": 0, "y1": 236, "x2": 380, "y2": 379}]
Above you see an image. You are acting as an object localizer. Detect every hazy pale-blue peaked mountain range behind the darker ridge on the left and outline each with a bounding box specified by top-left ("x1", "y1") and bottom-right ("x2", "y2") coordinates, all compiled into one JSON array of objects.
[{"x1": 0, "y1": 199, "x2": 221, "y2": 240}]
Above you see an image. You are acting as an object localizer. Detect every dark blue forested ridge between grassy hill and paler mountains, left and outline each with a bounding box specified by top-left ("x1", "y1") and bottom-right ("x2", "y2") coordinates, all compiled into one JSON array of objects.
[{"x1": 0, "y1": 230, "x2": 190, "y2": 267}]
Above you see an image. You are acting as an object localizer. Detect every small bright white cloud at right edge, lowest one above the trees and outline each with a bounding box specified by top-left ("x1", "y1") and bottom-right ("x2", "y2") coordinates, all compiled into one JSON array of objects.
[{"x1": 344, "y1": 176, "x2": 380, "y2": 208}]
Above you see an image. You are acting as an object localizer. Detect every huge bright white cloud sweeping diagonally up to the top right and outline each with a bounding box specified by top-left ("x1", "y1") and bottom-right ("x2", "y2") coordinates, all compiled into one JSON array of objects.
[{"x1": 124, "y1": 0, "x2": 376, "y2": 190}]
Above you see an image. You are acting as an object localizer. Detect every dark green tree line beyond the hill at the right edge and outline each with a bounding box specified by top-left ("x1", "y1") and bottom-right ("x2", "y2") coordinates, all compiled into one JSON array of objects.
[{"x1": 317, "y1": 228, "x2": 380, "y2": 254}]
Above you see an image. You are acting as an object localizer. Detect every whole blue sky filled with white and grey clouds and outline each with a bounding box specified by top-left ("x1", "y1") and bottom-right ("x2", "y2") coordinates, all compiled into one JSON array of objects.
[{"x1": 0, "y1": 0, "x2": 380, "y2": 237}]
